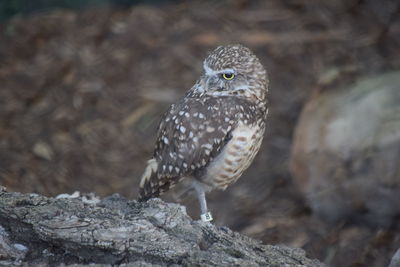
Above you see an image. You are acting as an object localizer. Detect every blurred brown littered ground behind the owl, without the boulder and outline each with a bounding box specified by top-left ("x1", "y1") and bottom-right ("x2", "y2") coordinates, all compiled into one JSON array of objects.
[{"x1": 0, "y1": 0, "x2": 400, "y2": 266}]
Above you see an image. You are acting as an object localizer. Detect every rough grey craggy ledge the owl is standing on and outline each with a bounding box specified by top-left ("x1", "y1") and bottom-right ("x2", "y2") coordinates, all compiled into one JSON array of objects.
[{"x1": 0, "y1": 191, "x2": 323, "y2": 266}]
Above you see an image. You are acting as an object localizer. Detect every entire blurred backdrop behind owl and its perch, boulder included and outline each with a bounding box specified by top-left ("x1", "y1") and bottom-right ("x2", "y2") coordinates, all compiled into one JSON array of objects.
[{"x1": 0, "y1": 0, "x2": 400, "y2": 266}]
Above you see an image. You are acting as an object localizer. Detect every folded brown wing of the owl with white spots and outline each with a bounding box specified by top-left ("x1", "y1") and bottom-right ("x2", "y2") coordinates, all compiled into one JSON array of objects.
[{"x1": 140, "y1": 97, "x2": 242, "y2": 200}]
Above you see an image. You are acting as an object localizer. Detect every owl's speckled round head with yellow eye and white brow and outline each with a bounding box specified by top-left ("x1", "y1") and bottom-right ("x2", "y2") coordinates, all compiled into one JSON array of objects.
[{"x1": 199, "y1": 44, "x2": 268, "y2": 101}]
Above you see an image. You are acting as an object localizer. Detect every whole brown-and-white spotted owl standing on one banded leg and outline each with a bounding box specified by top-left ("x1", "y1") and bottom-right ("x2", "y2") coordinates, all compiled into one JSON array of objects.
[{"x1": 139, "y1": 45, "x2": 268, "y2": 221}]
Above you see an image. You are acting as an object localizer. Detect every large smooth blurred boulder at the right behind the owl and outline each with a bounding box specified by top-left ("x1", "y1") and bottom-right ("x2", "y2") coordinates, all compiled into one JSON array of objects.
[{"x1": 290, "y1": 71, "x2": 400, "y2": 227}]
